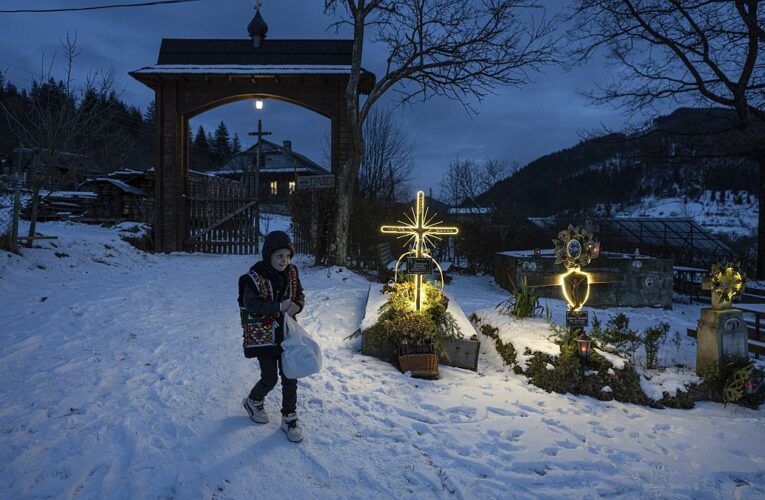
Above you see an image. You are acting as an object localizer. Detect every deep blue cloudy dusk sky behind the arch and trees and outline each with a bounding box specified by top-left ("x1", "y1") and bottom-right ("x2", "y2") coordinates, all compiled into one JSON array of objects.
[{"x1": 0, "y1": 0, "x2": 656, "y2": 196}]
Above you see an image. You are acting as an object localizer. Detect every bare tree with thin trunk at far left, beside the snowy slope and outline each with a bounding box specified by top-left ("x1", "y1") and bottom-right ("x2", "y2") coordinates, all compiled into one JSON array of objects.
[{"x1": 0, "y1": 34, "x2": 114, "y2": 247}]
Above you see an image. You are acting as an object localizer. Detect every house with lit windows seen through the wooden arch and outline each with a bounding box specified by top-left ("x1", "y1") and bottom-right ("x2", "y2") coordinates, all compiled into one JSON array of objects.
[{"x1": 207, "y1": 139, "x2": 329, "y2": 213}]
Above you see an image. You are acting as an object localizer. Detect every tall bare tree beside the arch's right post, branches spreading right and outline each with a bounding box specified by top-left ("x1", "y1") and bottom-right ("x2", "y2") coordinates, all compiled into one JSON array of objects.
[{"x1": 324, "y1": 0, "x2": 556, "y2": 265}]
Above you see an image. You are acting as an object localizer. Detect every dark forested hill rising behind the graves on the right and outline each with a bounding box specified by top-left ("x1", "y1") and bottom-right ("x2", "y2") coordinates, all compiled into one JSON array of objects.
[{"x1": 478, "y1": 108, "x2": 758, "y2": 216}]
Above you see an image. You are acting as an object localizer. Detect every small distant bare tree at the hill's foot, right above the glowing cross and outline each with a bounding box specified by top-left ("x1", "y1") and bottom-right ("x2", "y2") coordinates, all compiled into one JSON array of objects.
[{"x1": 441, "y1": 158, "x2": 508, "y2": 208}]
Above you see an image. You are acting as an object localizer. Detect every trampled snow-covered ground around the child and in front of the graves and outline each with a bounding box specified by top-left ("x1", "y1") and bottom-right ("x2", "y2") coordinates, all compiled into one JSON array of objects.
[{"x1": 0, "y1": 223, "x2": 765, "y2": 499}]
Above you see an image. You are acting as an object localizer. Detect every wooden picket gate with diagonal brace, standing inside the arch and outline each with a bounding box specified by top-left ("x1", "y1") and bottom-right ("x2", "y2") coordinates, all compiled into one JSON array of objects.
[{"x1": 185, "y1": 175, "x2": 258, "y2": 255}]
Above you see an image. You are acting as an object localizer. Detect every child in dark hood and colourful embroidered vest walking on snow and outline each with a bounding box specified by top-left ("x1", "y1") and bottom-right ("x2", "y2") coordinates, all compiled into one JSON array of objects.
[{"x1": 239, "y1": 231, "x2": 305, "y2": 442}]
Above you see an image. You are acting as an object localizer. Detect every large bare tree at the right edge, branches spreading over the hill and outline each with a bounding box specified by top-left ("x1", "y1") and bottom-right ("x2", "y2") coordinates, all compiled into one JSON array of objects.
[{"x1": 569, "y1": 0, "x2": 765, "y2": 278}]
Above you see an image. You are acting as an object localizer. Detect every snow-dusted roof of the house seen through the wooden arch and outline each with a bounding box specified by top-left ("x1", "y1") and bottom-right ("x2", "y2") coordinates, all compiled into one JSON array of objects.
[{"x1": 208, "y1": 139, "x2": 329, "y2": 175}]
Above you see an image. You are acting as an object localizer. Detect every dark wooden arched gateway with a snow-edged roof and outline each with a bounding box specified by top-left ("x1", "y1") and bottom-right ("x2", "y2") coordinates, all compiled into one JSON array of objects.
[{"x1": 130, "y1": 40, "x2": 374, "y2": 252}]
